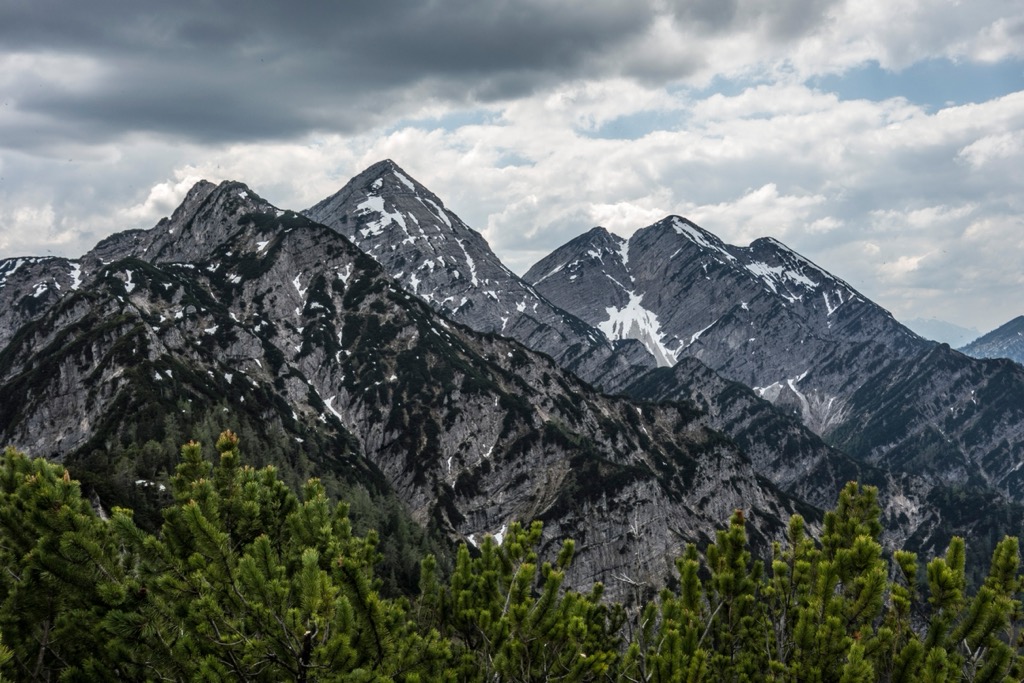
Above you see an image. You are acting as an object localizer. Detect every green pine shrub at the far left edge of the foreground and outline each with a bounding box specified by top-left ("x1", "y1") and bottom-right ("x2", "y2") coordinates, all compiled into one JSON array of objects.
[{"x1": 0, "y1": 449, "x2": 138, "y2": 680}]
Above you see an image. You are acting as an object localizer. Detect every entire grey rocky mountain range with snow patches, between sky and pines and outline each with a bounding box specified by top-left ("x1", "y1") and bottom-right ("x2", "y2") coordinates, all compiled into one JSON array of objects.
[{"x1": 0, "y1": 161, "x2": 1024, "y2": 596}]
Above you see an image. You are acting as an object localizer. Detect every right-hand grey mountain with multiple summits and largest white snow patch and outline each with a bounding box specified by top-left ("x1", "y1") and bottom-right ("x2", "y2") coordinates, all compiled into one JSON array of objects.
[{"x1": 524, "y1": 217, "x2": 1024, "y2": 511}]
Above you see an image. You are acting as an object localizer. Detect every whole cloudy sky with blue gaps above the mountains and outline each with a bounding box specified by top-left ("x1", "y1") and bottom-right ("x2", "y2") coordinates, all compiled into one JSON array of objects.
[{"x1": 0, "y1": 0, "x2": 1024, "y2": 331}]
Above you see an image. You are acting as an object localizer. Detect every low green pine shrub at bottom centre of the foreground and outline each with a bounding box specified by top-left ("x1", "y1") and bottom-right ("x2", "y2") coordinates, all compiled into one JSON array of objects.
[{"x1": 420, "y1": 522, "x2": 624, "y2": 682}]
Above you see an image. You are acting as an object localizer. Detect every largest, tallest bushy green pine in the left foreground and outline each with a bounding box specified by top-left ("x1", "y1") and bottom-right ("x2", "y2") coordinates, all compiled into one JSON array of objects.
[{"x1": 114, "y1": 432, "x2": 447, "y2": 681}]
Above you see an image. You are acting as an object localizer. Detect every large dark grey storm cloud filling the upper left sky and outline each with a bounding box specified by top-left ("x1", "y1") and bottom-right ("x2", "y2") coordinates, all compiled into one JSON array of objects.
[{"x1": 0, "y1": 0, "x2": 653, "y2": 146}]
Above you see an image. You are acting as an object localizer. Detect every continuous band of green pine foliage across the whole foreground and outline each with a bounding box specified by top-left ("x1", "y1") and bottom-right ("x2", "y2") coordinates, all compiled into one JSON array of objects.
[{"x1": 0, "y1": 432, "x2": 1024, "y2": 683}]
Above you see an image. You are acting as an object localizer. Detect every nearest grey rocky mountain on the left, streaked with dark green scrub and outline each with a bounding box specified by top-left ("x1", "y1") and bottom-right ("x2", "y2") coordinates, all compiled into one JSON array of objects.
[{"x1": 0, "y1": 182, "x2": 798, "y2": 597}]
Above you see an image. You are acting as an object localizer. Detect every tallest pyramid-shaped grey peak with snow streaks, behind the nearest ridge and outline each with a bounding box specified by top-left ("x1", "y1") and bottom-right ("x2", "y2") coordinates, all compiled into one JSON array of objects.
[{"x1": 303, "y1": 160, "x2": 653, "y2": 387}]
